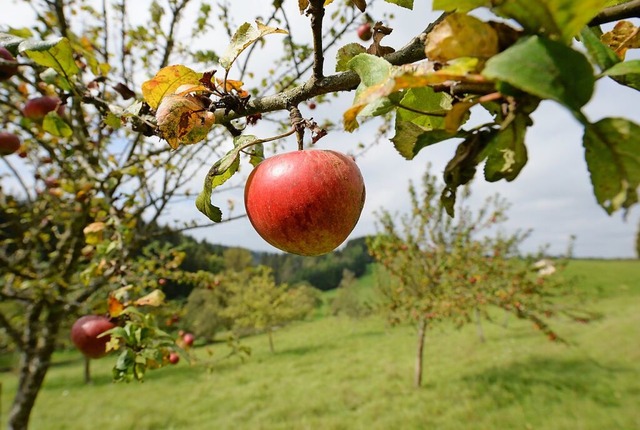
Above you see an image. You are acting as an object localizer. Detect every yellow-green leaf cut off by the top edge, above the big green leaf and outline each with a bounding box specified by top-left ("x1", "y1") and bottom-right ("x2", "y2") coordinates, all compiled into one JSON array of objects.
[{"x1": 492, "y1": 0, "x2": 607, "y2": 44}]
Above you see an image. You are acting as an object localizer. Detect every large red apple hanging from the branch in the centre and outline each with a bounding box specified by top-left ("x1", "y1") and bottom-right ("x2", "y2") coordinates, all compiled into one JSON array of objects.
[{"x1": 244, "y1": 150, "x2": 365, "y2": 256}]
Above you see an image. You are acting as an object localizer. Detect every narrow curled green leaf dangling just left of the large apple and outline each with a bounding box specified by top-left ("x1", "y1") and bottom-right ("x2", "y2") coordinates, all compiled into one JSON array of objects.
[{"x1": 196, "y1": 135, "x2": 259, "y2": 222}]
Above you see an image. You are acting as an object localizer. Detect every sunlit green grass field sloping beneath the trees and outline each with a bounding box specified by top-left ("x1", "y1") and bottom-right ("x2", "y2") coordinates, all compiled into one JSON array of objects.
[{"x1": 0, "y1": 261, "x2": 640, "y2": 430}]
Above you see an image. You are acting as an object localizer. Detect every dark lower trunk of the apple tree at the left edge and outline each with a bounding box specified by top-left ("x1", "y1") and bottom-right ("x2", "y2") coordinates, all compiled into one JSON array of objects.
[{"x1": 8, "y1": 304, "x2": 63, "y2": 430}]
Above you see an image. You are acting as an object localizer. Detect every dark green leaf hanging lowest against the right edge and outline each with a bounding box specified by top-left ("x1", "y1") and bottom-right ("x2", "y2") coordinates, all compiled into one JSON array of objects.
[{"x1": 583, "y1": 118, "x2": 640, "y2": 214}]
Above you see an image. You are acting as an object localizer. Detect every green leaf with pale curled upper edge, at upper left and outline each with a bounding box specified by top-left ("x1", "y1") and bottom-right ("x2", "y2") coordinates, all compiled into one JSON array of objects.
[{"x1": 18, "y1": 37, "x2": 80, "y2": 78}]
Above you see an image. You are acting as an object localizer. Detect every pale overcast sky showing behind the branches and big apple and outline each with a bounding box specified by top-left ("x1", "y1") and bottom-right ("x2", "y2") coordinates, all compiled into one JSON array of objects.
[{"x1": 5, "y1": 0, "x2": 640, "y2": 258}]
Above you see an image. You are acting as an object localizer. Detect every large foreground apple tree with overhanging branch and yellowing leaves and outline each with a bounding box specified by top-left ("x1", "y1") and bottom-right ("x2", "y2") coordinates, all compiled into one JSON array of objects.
[{"x1": 0, "y1": 0, "x2": 640, "y2": 429}]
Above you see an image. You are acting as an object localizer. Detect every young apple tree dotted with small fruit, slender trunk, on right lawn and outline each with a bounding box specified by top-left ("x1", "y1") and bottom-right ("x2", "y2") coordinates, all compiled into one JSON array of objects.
[{"x1": 369, "y1": 166, "x2": 588, "y2": 386}]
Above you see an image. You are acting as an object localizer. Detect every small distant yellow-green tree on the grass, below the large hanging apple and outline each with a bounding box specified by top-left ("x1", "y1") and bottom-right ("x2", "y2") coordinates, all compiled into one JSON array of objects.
[{"x1": 221, "y1": 266, "x2": 318, "y2": 352}]
